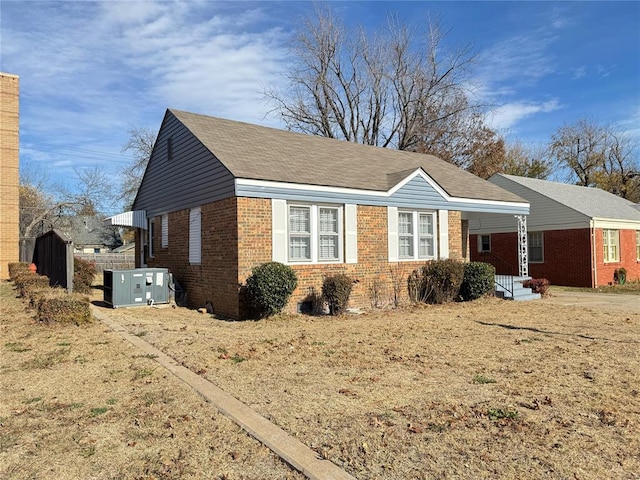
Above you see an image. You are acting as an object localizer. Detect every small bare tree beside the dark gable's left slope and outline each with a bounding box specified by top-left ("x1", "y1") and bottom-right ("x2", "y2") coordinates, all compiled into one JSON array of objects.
[{"x1": 121, "y1": 127, "x2": 156, "y2": 208}]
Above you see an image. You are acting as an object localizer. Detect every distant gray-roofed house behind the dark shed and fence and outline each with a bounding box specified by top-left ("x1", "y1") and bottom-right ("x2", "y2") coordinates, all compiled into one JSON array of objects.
[{"x1": 56, "y1": 215, "x2": 122, "y2": 253}]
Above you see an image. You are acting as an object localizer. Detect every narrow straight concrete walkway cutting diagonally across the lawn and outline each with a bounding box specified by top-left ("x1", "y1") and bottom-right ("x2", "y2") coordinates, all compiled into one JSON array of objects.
[{"x1": 92, "y1": 306, "x2": 355, "y2": 480}]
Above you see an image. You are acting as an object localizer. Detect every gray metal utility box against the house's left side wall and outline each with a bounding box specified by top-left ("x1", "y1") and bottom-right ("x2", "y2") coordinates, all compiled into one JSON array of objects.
[{"x1": 103, "y1": 268, "x2": 170, "y2": 308}]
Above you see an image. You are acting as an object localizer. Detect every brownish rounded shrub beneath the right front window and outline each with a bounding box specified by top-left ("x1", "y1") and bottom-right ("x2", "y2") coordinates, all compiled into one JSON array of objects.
[{"x1": 409, "y1": 258, "x2": 464, "y2": 304}]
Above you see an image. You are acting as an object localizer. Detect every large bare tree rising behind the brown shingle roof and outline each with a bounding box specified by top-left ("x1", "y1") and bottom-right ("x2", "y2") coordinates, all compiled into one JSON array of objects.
[{"x1": 265, "y1": 7, "x2": 486, "y2": 165}]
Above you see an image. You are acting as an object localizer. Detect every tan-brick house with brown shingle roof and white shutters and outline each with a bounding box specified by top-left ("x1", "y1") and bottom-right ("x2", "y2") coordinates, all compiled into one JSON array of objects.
[{"x1": 110, "y1": 110, "x2": 529, "y2": 318}]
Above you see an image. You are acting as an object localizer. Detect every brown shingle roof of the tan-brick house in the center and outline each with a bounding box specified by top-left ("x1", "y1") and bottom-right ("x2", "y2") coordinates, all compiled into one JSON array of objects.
[{"x1": 169, "y1": 109, "x2": 526, "y2": 203}]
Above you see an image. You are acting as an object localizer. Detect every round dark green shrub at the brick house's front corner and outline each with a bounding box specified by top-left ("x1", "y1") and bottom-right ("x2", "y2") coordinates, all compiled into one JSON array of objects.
[{"x1": 246, "y1": 262, "x2": 298, "y2": 317}]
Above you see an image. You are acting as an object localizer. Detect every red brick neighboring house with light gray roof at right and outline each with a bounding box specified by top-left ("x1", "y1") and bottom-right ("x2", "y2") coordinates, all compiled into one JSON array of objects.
[{"x1": 469, "y1": 174, "x2": 640, "y2": 287}]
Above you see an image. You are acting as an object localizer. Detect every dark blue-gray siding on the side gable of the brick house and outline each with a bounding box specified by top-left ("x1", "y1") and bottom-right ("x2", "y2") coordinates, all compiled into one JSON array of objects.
[{"x1": 133, "y1": 112, "x2": 234, "y2": 218}]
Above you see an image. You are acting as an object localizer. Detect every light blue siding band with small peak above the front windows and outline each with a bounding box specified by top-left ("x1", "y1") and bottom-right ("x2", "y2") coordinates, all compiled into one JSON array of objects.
[{"x1": 236, "y1": 176, "x2": 529, "y2": 215}]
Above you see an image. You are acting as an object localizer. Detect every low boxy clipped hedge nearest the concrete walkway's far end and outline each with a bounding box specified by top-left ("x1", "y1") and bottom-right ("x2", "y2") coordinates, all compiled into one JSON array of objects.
[{"x1": 36, "y1": 288, "x2": 92, "y2": 325}]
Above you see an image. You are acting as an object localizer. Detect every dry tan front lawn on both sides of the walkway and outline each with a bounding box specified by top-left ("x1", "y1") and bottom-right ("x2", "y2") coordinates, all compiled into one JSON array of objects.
[{"x1": 0, "y1": 278, "x2": 640, "y2": 479}]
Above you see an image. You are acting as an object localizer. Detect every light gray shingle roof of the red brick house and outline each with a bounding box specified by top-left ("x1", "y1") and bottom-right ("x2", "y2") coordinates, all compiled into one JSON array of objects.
[{"x1": 499, "y1": 174, "x2": 640, "y2": 221}]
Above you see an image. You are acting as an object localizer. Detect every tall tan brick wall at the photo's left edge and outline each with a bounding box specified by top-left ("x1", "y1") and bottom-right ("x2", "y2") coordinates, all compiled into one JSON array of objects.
[{"x1": 0, "y1": 73, "x2": 20, "y2": 279}]
